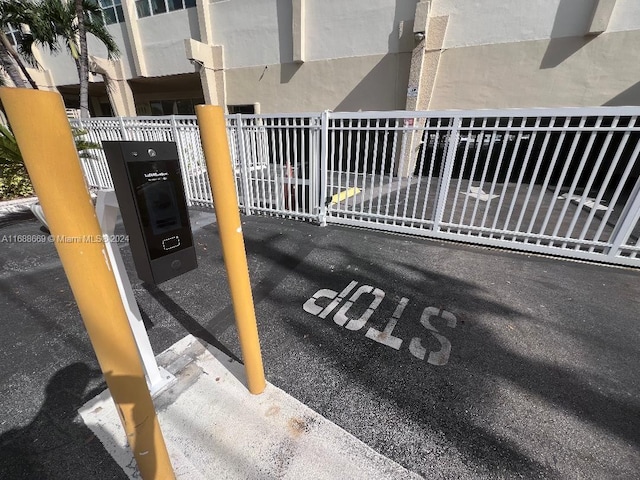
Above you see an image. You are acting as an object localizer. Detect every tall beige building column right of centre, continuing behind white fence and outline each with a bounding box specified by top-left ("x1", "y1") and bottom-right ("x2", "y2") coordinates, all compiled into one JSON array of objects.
[{"x1": 398, "y1": 0, "x2": 449, "y2": 177}]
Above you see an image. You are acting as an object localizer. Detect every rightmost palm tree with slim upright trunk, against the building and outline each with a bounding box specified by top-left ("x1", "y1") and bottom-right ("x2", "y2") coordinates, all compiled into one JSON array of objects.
[{"x1": 20, "y1": 0, "x2": 119, "y2": 117}]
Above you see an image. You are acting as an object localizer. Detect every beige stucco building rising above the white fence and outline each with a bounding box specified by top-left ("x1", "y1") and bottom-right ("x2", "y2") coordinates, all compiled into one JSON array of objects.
[{"x1": 11, "y1": 0, "x2": 640, "y2": 116}]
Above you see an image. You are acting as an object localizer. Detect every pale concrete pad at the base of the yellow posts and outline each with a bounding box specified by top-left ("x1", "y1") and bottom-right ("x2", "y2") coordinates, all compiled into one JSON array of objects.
[{"x1": 79, "y1": 335, "x2": 422, "y2": 480}]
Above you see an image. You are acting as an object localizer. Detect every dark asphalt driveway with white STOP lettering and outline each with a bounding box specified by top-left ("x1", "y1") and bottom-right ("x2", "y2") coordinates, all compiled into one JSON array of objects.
[{"x1": 0, "y1": 204, "x2": 640, "y2": 479}]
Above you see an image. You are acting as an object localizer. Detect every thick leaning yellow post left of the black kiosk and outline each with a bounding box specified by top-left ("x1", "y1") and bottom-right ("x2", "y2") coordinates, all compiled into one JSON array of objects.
[{"x1": 0, "y1": 88, "x2": 175, "y2": 480}]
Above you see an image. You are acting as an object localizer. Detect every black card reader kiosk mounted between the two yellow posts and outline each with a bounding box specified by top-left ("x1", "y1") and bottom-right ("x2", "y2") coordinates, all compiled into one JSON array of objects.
[{"x1": 102, "y1": 141, "x2": 197, "y2": 284}]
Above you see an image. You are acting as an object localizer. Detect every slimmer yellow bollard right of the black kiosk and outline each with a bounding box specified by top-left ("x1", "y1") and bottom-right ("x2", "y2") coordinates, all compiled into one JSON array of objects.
[{"x1": 196, "y1": 105, "x2": 265, "y2": 395}]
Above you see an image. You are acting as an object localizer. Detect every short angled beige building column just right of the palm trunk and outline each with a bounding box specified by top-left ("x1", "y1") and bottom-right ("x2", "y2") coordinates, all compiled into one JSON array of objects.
[{"x1": 89, "y1": 56, "x2": 136, "y2": 117}]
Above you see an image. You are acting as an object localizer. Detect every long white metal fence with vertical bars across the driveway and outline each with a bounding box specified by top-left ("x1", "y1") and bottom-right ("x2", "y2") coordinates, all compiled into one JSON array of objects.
[{"x1": 72, "y1": 107, "x2": 640, "y2": 266}]
